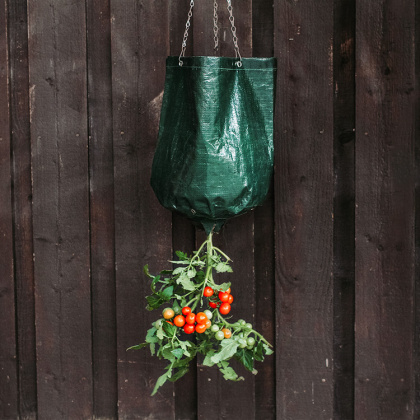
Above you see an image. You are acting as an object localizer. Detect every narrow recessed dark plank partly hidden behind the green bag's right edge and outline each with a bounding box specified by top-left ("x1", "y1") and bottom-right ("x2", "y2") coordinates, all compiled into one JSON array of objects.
[{"x1": 252, "y1": 0, "x2": 277, "y2": 420}]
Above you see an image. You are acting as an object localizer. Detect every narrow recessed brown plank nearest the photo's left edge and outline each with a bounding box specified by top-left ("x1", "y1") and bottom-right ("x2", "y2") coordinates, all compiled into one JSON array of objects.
[{"x1": 9, "y1": 1, "x2": 37, "y2": 419}]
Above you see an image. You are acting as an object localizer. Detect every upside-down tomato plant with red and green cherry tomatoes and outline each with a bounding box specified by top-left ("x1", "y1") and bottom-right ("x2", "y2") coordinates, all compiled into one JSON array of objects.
[{"x1": 130, "y1": 233, "x2": 273, "y2": 395}]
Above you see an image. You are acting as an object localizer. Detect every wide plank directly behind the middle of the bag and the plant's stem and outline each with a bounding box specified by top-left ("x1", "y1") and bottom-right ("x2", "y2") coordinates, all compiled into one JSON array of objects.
[{"x1": 193, "y1": 0, "x2": 256, "y2": 419}]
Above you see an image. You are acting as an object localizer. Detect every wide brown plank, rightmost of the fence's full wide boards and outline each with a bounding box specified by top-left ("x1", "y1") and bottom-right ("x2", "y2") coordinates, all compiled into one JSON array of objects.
[{"x1": 355, "y1": 0, "x2": 416, "y2": 420}]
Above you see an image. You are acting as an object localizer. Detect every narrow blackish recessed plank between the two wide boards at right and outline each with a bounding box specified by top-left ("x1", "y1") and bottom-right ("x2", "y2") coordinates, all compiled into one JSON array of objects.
[{"x1": 333, "y1": 1, "x2": 356, "y2": 420}]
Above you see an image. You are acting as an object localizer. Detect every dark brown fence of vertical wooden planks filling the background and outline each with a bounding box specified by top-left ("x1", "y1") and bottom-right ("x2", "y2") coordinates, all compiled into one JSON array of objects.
[{"x1": 0, "y1": 0, "x2": 420, "y2": 420}]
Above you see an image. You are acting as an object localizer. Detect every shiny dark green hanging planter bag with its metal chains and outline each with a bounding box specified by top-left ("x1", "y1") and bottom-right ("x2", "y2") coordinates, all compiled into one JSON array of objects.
[{"x1": 151, "y1": 0, "x2": 276, "y2": 234}]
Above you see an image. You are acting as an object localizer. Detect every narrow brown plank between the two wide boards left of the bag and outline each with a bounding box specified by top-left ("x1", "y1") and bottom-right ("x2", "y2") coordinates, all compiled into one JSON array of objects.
[{"x1": 86, "y1": 0, "x2": 118, "y2": 418}]
